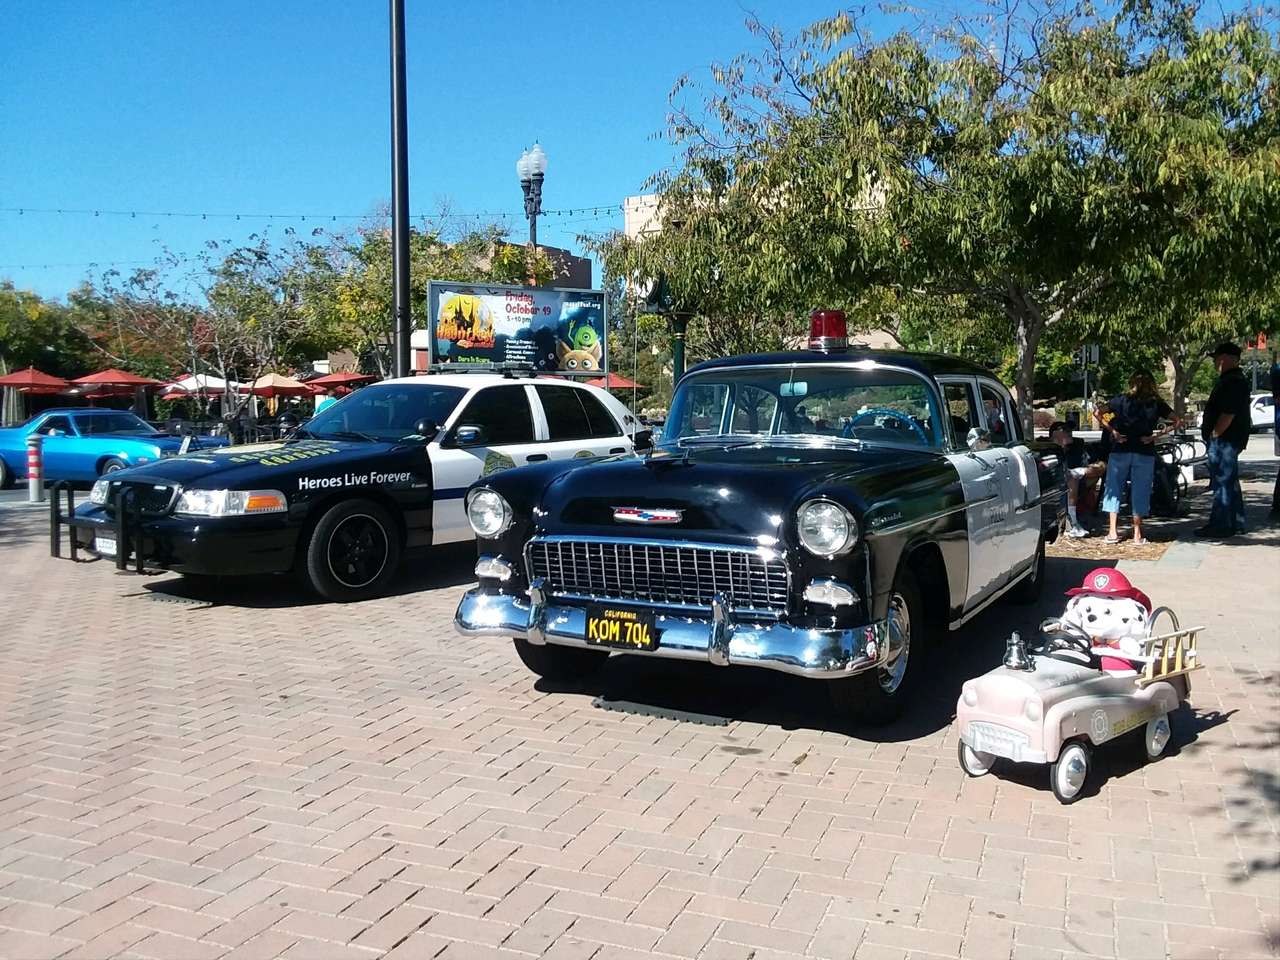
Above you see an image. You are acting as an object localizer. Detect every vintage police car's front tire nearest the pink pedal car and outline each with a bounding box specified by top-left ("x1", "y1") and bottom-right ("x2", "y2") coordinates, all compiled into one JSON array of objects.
[{"x1": 822, "y1": 570, "x2": 929, "y2": 727}]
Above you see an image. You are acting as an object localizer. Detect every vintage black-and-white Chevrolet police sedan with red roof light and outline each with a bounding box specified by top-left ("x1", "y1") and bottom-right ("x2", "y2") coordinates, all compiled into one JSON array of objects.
[{"x1": 454, "y1": 311, "x2": 1065, "y2": 723}]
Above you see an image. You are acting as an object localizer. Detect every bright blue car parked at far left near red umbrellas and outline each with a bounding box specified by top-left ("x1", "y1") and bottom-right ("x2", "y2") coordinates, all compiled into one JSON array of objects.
[{"x1": 0, "y1": 408, "x2": 227, "y2": 488}]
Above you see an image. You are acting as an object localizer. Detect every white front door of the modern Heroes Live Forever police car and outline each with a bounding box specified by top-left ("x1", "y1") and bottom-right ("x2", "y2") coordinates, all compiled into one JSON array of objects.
[{"x1": 428, "y1": 384, "x2": 543, "y2": 543}]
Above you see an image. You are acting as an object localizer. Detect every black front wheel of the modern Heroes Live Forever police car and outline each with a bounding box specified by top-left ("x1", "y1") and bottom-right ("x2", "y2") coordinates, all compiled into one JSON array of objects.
[{"x1": 302, "y1": 500, "x2": 401, "y2": 603}]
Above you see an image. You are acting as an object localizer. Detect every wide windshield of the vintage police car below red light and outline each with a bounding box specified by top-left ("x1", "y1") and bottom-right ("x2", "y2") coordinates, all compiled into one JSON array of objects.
[{"x1": 662, "y1": 364, "x2": 942, "y2": 448}]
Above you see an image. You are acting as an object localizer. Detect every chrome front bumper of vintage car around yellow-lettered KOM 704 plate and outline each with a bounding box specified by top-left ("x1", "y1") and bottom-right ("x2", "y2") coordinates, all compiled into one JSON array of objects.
[{"x1": 453, "y1": 584, "x2": 888, "y2": 680}]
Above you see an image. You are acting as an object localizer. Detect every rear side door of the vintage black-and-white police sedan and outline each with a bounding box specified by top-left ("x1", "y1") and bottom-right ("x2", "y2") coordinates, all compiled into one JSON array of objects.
[{"x1": 978, "y1": 379, "x2": 1041, "y2": 580}]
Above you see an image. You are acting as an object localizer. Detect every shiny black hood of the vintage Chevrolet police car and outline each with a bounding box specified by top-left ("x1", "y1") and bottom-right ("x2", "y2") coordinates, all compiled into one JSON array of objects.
[{"x1": 524, "y1": 444, "x2": 943, "y2": 543}]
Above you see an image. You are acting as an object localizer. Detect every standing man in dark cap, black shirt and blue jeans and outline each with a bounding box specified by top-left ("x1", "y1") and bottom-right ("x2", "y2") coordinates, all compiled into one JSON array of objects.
[{"x1": 1196, "y1": 343, "x2": 1253, "y2": 538}]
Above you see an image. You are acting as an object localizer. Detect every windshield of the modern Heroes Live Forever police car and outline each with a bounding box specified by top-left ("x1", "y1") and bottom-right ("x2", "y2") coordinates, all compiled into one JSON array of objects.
[{"x1": 305, "y1": 383, "x2": 466, "y2": 440}]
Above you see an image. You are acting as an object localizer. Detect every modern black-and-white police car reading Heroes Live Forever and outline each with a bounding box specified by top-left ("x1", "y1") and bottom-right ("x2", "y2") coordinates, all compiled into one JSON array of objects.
[{"x1": 52, "y1": 371, "x2": 648, "y2": 600}]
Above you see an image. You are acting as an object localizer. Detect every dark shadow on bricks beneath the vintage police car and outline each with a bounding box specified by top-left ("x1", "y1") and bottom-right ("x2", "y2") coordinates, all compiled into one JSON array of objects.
[{"x1": 536, "y1": 557, "x2": 1112, "y2": 747}]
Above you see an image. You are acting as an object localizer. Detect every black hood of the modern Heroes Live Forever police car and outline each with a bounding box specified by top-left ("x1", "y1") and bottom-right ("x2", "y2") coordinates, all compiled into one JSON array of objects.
[{"x1": 105, "y1": 439, "x2": 403, "y2": 490}]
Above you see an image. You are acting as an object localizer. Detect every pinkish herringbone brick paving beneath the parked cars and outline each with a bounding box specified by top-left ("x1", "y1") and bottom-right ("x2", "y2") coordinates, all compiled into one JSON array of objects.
[{"x1": 0, "y1": 476, "x2": 1280, "y2": 960}]
